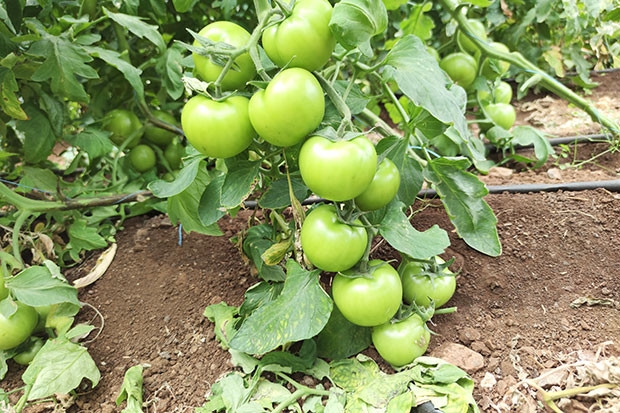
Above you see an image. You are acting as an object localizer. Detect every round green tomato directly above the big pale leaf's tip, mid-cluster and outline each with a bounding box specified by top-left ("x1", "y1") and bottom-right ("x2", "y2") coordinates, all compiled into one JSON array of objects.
[{"x1": 300, "y1": 204, "x2": 368, "y2": 272}]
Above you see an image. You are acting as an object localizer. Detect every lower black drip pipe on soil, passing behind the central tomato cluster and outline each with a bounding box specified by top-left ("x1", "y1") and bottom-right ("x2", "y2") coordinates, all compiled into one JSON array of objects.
[{"x1": 243, "y1": 179, "x2": 620, "y2": 209}]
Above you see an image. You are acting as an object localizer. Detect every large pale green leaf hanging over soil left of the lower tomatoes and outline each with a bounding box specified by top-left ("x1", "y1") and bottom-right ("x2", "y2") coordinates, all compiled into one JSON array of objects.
[{"x1": 230, "y1": 260, "x2": 333, "y2": 354}]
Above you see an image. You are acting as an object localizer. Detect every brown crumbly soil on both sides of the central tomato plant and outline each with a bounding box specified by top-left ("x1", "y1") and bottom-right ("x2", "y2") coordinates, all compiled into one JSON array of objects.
[{"x1": 2, "y1": 72, "x2": 620, "y2": 413}]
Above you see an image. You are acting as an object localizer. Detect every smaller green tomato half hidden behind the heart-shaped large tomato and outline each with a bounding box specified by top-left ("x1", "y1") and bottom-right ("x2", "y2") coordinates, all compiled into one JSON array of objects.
[{"x1": 355, "y1": 158, "x2": 400, "y2": 211}]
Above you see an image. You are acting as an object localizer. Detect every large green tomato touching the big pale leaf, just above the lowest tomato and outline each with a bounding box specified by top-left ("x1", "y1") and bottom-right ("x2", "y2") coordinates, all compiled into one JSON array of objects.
[{"x1": 332, "y1": 260, "x2": 403, "y2": 327}]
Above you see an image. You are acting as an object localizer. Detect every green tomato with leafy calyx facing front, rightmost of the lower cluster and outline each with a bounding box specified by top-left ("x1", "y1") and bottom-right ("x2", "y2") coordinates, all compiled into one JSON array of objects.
[{"x1": 398, "y1": 257, "x2": 456, "y2": 308}]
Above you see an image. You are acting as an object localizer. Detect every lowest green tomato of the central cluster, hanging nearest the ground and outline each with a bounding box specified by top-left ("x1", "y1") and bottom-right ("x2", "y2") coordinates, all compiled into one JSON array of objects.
[{"x1": 372, "y1": 314, "x2": 431, "y2": 367}]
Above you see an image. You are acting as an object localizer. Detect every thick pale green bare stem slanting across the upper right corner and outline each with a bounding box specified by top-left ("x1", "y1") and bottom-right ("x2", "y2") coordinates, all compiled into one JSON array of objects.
[{"x1": 439, "y1": 0, "x2": 620, "y2": 139}]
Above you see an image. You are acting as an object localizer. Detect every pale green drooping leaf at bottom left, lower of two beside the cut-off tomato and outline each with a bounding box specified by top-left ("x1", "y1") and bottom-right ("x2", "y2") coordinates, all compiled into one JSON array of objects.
[{"x1": 22, "y1": 337, "x2": 101, "y2": 400}]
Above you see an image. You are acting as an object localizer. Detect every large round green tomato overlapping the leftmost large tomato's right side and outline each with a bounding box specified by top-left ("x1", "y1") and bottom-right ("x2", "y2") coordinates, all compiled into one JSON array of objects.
[{"x1": 249, "y1": 68, "x2": 325, "y2": 146}]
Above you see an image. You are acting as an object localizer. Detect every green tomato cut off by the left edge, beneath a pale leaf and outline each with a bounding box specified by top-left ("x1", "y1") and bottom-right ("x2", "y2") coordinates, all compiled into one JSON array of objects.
[{"x1": 0, "y1": 298, "x2": 39, "y2": 351}]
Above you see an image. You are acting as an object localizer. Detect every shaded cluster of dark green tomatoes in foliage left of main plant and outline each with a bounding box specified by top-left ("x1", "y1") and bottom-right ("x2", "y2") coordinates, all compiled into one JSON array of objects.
[{"x1": 102, "y1": 108, "x2": 185, "y2": 176}]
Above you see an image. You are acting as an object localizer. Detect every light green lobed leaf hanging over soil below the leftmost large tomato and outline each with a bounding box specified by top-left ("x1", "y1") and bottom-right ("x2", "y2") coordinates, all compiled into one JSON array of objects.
[{"x1": 167, "y1": 168, "x2": 224, "y2": 235}]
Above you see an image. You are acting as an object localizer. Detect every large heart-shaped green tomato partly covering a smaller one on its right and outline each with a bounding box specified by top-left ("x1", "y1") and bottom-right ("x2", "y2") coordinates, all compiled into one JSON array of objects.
[{"x1": 299, "y1": 136, "x2": 377, "y2": 201}]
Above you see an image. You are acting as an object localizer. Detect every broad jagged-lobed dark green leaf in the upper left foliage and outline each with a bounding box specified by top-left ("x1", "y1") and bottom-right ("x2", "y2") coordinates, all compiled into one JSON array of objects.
[{"x1": 28, "y1": 34, "x2": 99, "y2": 102}]
